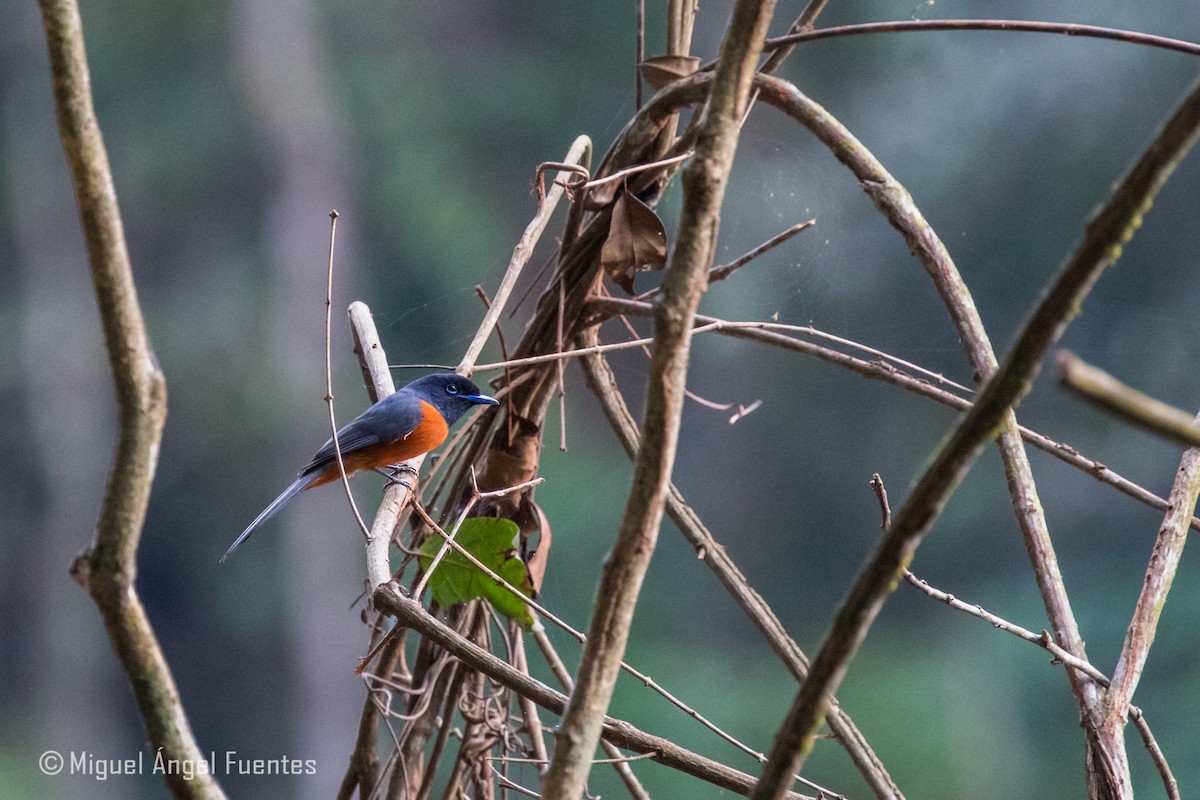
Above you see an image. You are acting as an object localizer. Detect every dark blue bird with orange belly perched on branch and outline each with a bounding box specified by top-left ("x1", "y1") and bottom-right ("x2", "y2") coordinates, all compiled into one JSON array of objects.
[{"x1": 221, "y1": 372, "x2": 497, "y2": 561}]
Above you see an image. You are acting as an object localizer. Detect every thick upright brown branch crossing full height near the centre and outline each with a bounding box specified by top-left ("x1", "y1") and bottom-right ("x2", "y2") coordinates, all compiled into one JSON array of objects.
[{"x1": 542, "y1": 0, "x2": 775, "y2": 800}]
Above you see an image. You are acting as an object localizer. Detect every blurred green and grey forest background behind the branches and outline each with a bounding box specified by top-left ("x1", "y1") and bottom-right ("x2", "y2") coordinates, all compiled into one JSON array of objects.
[{"x1": 0, "y1": 0, "x2": 1200, "y2": 800}]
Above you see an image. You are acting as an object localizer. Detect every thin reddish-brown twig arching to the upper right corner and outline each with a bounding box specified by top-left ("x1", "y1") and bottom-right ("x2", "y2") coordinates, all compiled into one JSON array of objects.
[{"x1": 763, "y1": 19, "x2": 1200, "y2": 55}]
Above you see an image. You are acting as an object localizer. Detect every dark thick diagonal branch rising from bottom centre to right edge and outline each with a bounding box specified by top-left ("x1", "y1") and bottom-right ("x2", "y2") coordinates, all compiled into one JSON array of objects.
[{"x1": 751, "y1": 70, "x2": 1200, "y2": 798}]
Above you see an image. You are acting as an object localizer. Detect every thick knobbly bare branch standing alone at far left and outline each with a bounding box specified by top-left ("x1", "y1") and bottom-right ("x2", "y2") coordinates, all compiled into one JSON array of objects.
[{"x1": 38, "y1": 0, "x2": 224, "y2": 800}]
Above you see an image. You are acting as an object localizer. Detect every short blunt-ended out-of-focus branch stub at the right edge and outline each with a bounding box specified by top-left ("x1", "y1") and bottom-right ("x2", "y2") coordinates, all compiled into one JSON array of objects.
[{"x1": 1055, "y1": 350, "x2": 1200, "y2": 447}]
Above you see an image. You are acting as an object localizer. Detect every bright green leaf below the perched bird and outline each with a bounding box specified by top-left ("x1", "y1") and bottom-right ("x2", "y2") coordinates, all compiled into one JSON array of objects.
[{"x1": 419, "y1": 517, "x2": 533, "y2": 628}]
